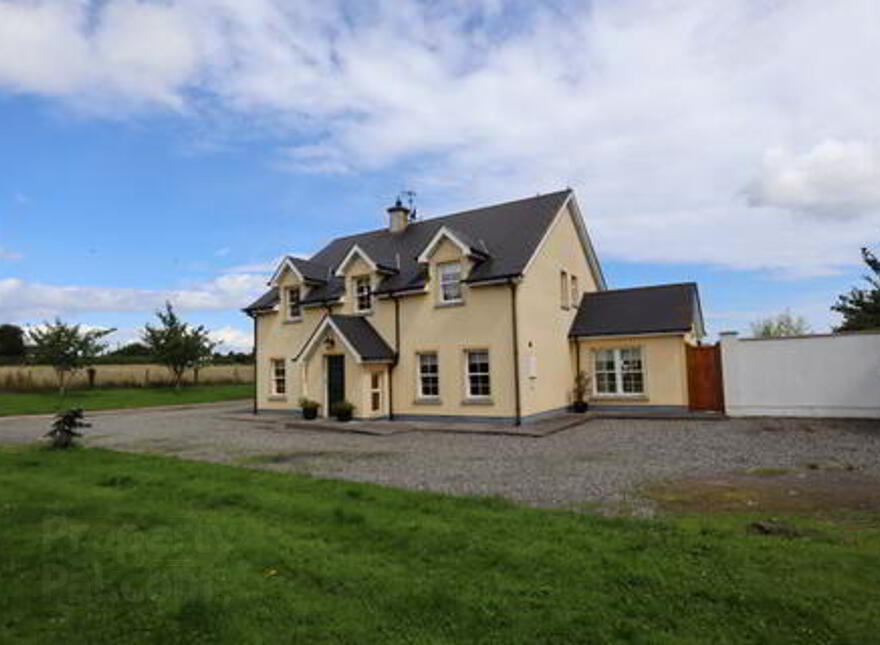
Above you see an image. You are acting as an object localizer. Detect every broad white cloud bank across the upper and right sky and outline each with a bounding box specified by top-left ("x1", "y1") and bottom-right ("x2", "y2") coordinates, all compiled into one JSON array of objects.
[{"x1": 0, "y1": 0, "x2": 880, "y2": 274}]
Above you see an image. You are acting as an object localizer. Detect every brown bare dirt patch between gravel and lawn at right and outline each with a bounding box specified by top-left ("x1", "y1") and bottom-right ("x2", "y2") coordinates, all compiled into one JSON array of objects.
[{"x1": 643, "y1": 470, "x2": 880, "y2": 516}]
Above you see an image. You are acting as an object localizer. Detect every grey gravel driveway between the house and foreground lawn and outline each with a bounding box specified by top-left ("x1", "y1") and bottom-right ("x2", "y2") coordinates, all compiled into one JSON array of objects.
[{"x1": 0, "y1": 403, "x2": 880, "y2": 508}]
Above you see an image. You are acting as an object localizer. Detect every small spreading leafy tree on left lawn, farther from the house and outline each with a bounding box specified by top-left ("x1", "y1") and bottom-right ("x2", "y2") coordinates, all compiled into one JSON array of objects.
[{"x1": 28, "y1": 318, "x2": 116, "y2": 396}]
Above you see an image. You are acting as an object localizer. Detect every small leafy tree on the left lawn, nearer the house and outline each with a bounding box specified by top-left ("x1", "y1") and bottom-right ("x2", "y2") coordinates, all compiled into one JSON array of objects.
[{"x1": 141, "y1": 302, "x2": 217, "y2": 390}]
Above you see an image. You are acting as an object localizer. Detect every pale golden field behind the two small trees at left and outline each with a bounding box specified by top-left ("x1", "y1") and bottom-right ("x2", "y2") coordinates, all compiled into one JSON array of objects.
[{"x1": 0, "y1": 365, "x2": 254, "y2": 392}]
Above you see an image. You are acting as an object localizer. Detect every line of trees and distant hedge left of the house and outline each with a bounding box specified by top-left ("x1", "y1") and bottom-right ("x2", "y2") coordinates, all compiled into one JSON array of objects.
[{"x1": 0, "y1": 303, "x2": 253, "y2": 394}]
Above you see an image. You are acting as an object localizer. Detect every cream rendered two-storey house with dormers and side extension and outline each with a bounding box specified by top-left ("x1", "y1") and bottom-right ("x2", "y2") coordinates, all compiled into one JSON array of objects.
[{"x1": 244, "y1": 190, "x2": 703, "y2": 423}]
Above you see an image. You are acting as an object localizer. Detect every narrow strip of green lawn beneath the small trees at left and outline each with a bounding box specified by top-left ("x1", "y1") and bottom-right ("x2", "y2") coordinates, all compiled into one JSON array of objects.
[{"x1": 0, "y1": 383, "x2": 254, "y2": 416}]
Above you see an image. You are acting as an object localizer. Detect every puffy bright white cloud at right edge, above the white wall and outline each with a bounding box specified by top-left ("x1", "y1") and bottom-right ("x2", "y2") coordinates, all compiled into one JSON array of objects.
[{"x1": 751, "y1": 139, "x2": 880, "y2": 218}]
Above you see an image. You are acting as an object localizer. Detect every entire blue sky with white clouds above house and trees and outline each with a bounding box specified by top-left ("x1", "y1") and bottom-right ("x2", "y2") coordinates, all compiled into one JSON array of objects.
[{"x1": 0, "y1": 0, "x2": 880, "y2": 349}]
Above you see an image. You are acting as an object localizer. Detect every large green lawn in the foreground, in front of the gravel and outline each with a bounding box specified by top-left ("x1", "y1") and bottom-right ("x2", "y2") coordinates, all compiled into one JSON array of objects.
[{"x1": 0, "y1": 448, "x2": 880, "y2": 644}]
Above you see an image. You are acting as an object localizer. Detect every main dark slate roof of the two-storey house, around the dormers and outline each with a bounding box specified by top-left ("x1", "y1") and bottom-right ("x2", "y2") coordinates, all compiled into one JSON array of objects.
[{"x1": 245, "y1": 189, "x2": 571, "y2": 311}]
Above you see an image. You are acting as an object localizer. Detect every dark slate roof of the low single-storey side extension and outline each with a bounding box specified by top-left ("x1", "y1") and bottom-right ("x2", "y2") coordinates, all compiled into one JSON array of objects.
[{"x1": 569, "y1": 282, "x2": 703, "y2": 337}]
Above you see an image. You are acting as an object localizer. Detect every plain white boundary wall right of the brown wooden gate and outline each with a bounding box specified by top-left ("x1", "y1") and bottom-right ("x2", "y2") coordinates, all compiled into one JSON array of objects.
[{"x1": 721, "y1": 332, "x2": 880, "y2": 418}]
